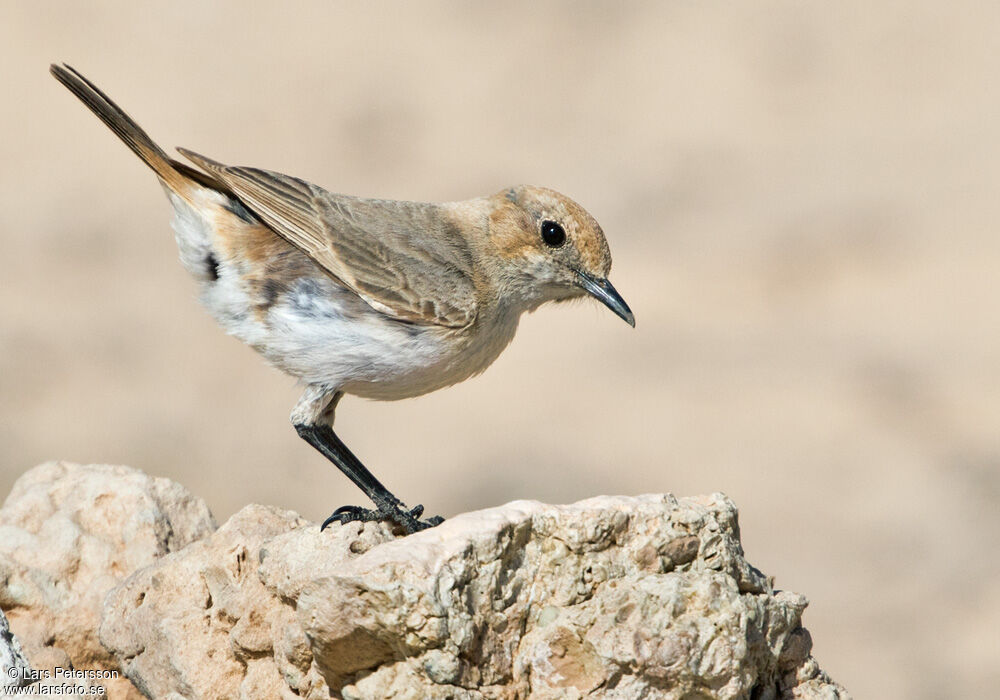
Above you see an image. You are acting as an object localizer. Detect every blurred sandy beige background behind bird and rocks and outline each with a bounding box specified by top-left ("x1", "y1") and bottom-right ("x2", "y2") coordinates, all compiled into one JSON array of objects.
[{"x1": 0, "y1": 1, "x2": 1000, "y2": 699}]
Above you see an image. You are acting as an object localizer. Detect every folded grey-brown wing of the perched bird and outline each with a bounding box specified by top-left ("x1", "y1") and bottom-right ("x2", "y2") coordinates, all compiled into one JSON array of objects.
[{"x1": 177, "y1": 148, "x2": 476, "y2": 328}]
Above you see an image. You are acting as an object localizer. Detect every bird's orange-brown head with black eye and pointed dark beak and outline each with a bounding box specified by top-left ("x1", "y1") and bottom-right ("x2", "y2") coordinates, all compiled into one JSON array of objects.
[{"x1": 489, "y1": 185, "x2": 635, "y2": 327}]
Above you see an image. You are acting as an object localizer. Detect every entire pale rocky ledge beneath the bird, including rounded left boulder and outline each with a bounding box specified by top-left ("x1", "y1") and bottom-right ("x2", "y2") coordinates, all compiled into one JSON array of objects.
[{"x1": 0, "y1": 462, "x2": 848, "y2": 700}]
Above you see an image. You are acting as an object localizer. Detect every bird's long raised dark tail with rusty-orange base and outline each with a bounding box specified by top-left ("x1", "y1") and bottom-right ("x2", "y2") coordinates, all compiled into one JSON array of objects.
[{"x1": 49, "y1": 64, "x2": 208, "y2": 196}]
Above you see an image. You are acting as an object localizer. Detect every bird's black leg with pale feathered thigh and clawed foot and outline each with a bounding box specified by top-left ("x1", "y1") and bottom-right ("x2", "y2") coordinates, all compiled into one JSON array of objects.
[{"x1": 292, "y1": 387, "x2": 443, "y2": 534}]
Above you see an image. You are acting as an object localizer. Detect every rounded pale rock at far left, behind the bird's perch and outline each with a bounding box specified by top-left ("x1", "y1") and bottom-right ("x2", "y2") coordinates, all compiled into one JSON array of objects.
[{"x1": 0, "y1": 462, "x2": 215, "y2": 697}]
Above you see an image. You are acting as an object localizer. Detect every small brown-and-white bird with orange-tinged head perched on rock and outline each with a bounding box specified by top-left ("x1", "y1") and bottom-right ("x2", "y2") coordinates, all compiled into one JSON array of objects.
[{"x1": 50, "y1": 64, "x2": 635, "y2": 534}]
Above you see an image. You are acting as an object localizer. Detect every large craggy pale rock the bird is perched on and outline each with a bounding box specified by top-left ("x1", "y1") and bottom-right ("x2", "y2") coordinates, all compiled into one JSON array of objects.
[{"x1": 94, "y1": 495, "x2": 848, "y2": 700}]
